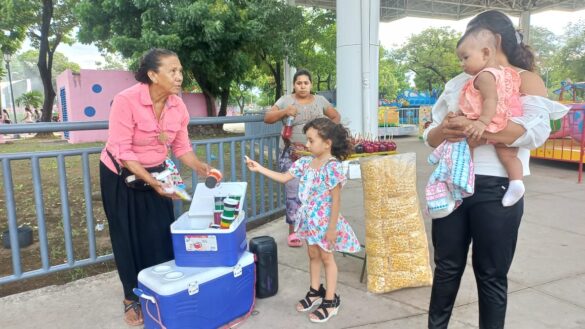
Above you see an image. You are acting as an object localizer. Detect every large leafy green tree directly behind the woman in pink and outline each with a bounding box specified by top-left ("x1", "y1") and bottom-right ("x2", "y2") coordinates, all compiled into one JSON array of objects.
[{"x1": 76, "y1": 0, "x2": 254, "y2": 116}]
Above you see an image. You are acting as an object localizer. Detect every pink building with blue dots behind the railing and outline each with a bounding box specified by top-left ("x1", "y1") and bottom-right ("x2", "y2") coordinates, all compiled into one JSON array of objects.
[{"x1": 57, "y1": 70, "x2": 207, "y2": 144}]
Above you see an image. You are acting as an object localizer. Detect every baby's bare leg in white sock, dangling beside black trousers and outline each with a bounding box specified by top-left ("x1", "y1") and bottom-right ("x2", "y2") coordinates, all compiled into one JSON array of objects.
[{"x1": 496, "y1": 145, "x2": 526, "y2": 207}]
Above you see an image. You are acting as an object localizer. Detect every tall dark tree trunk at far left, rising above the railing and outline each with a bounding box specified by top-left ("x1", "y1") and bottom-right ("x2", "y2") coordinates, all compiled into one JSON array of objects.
[{"x1": 37, "y1": 0, "x2": 57, "y2": 122}]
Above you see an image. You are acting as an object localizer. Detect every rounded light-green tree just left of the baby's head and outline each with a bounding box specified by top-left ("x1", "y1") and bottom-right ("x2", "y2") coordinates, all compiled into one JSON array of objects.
[{"x1": 397, "y1": 27, "x2": 461, "y2": 90}]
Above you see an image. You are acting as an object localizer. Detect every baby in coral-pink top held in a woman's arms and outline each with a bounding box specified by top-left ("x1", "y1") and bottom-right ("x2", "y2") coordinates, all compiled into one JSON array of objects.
[{"x1": 457, "y1": 29, "x2": 525, "y2": 207}]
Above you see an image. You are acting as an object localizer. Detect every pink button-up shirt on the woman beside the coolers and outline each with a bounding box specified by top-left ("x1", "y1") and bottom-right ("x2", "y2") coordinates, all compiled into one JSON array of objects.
[{"x1": 100, "y1": 83, "x2": 193, "y2": 173}]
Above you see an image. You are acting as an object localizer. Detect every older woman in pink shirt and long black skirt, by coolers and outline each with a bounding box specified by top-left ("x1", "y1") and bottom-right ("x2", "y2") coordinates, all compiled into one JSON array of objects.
[{"x1": 100, "y1": 49, "x2": 210, "y2": 326}]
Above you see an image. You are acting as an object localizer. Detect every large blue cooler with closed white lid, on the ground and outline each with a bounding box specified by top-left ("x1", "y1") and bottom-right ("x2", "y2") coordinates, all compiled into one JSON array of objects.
[{"x1": 135, "y1": 251, "x2": 255, "y2": 329}]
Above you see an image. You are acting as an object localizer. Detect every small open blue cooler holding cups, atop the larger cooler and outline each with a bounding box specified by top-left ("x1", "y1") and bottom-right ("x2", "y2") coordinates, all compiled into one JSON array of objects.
[{"x1": 171, "y1": 182, "x2": 247, "y2": 267}]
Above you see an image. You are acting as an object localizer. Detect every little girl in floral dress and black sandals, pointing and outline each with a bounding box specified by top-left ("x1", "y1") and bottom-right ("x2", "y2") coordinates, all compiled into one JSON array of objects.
[{"x1": 246, "y1": 118, "x2": 360, "y2": 322}]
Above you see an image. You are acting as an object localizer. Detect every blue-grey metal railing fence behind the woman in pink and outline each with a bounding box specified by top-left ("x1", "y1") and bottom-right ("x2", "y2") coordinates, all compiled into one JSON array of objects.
[{"x1": 0, "y1": 116, "x2": 284, "y2": 285}]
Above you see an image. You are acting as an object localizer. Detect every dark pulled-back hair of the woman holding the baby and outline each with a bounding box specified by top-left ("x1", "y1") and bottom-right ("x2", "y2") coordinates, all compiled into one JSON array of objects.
[{"x1": 462, "y1": 10, "x2": 534, "y2": 71}]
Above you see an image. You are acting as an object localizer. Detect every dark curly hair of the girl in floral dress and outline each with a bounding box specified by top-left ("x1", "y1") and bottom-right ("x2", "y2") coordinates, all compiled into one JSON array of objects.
[{"x1": 303, "y1": 118, "x2": 351, "y2": 161}]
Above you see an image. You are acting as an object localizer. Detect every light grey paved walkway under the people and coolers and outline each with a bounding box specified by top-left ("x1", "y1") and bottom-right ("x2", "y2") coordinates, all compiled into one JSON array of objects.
[{"x1": 0, "y1": 138, "x2": 585, "y2": 329}]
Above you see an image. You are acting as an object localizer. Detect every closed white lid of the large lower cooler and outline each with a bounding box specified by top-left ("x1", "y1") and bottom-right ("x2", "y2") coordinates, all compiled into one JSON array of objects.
[{"x1": 138, "y1": 251, "x2": 254, "y2": 296}]
